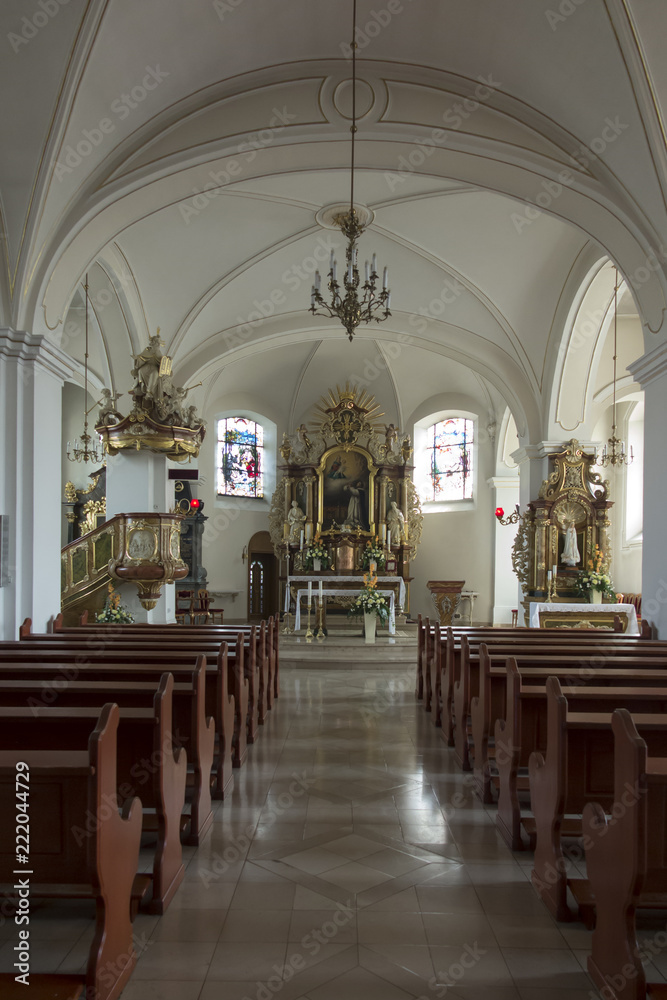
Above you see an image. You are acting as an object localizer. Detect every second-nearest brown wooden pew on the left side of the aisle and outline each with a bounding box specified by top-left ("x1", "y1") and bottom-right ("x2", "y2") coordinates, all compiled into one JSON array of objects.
[{"x1": 0, "y1": 674, "x2": 187, "y2": 914}]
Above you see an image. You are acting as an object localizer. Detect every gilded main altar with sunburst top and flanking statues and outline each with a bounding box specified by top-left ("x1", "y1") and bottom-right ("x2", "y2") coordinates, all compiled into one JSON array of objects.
[{"x1": 269, "y1": 385, "x2": 422, "y2": 614}]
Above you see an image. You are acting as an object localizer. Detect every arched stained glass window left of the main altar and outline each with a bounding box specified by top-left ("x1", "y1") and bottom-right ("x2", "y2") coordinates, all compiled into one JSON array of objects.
[{"x1": 217, "y1": 417, "x2": 264, "y2": 497}]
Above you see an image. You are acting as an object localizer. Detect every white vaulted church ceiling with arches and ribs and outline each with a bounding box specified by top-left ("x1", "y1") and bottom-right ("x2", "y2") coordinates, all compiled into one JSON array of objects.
[{"x1": 0, "y1": 0, "x2": 667, "y2": 448}]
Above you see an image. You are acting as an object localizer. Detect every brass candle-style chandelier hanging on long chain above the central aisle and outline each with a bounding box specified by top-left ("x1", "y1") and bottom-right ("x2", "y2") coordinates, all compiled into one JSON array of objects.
[{"x1": 309, "y1": 0, "x2": 391, "y2": 341}]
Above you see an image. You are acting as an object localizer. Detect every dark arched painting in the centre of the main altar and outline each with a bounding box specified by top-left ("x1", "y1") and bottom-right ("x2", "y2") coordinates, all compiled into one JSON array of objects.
[{"x1": 320, "y1": 448, "x2": 372, "y2": 531}]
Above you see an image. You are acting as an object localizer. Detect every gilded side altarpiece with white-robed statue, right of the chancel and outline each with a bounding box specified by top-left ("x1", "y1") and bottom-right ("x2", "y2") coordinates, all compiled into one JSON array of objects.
[{"x1": 512, "y1": 438, "x2": 613, "y2": 624}]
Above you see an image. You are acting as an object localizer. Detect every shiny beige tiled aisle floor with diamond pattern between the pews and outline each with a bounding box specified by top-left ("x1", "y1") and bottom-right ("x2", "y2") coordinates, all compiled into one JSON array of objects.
[{"x1": 0, "y1": 668, "x2": 667, "y2": 1000}]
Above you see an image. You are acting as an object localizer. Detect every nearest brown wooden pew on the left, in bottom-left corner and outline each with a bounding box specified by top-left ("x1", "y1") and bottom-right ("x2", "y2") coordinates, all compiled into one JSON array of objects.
[{"x1": 0, "y1": 704, "x2": 141, "y2": 1000}]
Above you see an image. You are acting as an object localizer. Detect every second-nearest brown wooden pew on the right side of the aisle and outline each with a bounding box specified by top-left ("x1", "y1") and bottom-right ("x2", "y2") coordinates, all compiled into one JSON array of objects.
[{"x1": 529, "y1": 677, "x2": 667, "y2": 927}]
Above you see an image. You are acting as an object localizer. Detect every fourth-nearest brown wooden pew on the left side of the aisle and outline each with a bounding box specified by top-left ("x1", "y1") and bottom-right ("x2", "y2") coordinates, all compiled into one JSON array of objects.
[{"x1": 0, "y1": 626, "x2": 244, "y2": 798}]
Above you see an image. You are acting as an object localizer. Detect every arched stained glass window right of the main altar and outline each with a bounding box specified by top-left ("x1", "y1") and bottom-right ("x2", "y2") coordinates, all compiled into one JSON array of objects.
[{"x1": 423, "y1": 417, "x2": 474, "y2": 501}]
